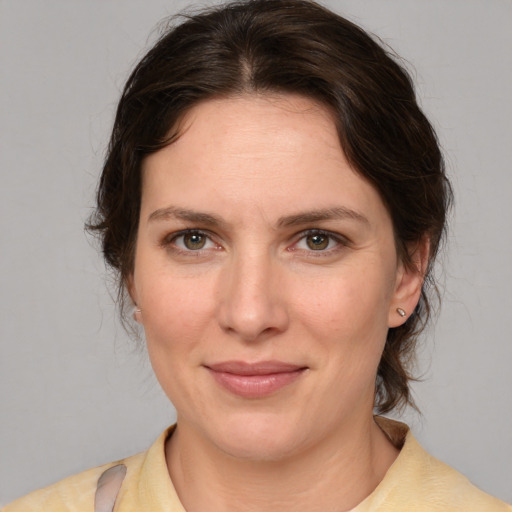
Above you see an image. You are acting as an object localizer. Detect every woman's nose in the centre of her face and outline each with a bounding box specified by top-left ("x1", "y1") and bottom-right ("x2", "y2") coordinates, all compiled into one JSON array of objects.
[{"x1": 218, "y1": 250, "x2": 289, "y2": 342}]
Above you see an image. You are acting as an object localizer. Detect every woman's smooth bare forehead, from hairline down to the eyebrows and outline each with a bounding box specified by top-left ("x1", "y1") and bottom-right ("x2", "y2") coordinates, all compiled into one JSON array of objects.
[{"x1": 141, "y1": 95, "x2": 383, "y2": 228}]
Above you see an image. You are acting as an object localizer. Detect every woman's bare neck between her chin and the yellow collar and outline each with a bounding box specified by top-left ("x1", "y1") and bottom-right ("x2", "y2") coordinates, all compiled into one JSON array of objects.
[{"x1": 166, "y1": 415, "x2": 398, "y2": 512}]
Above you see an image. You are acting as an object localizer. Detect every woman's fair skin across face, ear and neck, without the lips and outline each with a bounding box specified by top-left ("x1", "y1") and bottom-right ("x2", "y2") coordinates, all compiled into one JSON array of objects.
[{"x1": 128, "y1": 95, "x2": 426, "y2": 512}]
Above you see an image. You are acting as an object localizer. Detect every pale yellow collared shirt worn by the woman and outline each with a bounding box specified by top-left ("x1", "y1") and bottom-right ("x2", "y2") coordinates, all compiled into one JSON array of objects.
[{"x1": 1, "y1": 418, "x2": 512, "y2": 512}]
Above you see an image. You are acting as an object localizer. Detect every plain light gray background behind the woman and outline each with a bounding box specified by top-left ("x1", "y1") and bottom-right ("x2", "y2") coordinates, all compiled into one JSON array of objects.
[{"x1": 0, "y1": 0, "x2": 512, "y2": 504}]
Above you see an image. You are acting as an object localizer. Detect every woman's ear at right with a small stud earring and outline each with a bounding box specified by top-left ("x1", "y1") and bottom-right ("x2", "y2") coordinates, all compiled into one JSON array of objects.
[{"x1": 388, "y1": 236, "x2": 430, "y2": 327}]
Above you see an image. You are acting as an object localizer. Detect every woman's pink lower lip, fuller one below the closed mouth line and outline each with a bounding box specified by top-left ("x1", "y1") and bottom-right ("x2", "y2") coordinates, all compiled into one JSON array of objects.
[{"x1": 210, "y1": 368, "x2": 304, "y2": 398}]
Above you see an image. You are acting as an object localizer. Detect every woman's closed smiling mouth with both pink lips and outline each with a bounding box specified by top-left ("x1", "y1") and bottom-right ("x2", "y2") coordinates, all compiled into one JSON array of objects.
[{"x1": 205, "y1": 361, "x2": 307, "y2": 398}]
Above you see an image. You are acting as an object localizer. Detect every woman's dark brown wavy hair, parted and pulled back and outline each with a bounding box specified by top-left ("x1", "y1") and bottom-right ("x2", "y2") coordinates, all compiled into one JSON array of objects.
[{"x1": 88, "y1": 0, "x2": 451, "y2": 412}]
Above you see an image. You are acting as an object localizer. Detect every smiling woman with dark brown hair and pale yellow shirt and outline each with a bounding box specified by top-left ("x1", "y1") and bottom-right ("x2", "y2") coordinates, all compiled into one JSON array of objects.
[{"x1": 5, "y1": 0, "x2": 511, "y2": 512}]
